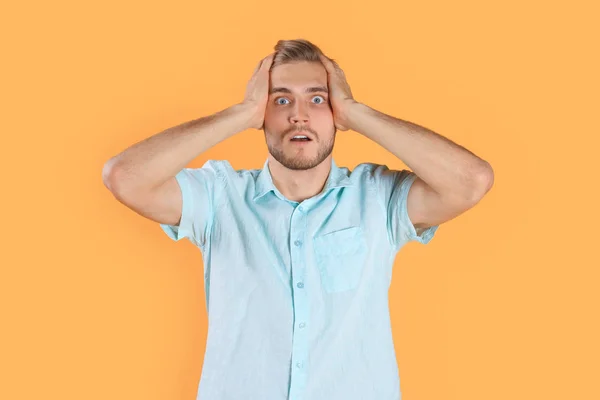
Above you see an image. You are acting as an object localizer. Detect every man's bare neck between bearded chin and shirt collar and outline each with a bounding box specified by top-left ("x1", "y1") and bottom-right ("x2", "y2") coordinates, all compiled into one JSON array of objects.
[{"x1": 268, "y1": 155, "x2": 331, "y2": 202}]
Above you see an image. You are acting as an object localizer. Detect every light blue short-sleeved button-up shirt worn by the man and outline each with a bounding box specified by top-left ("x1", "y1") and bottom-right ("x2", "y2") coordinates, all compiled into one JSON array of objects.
[{"x1": 160, "y1": 159, "x2": 438, "y2": 400}]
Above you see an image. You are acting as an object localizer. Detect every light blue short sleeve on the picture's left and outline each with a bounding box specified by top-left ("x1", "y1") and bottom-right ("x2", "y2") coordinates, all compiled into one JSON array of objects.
[{"x1": 160, "y1": 160, "x2": 224, "y2": 249}]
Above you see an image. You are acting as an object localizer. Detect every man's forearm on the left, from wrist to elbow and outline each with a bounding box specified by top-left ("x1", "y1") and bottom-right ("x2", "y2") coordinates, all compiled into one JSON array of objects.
[{"x1": 102, "y1": 104, "x2": 251, "y2": 195}]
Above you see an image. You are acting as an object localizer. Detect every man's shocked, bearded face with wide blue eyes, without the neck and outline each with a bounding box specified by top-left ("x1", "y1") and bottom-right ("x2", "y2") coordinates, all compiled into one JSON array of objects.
[{"x1": 264, "y1": 61, "x2": 336, "y2": 170}]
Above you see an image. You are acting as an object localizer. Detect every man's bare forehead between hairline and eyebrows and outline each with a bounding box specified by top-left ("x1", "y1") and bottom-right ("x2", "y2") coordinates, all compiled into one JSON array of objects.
[{"x1": 270, "y1": 61, "x2": 327, "y2": 90}]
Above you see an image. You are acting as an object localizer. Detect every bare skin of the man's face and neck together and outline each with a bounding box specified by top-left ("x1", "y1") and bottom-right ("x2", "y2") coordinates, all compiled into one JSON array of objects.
[{"x1": 264, "y1": 61, "x2": 336, "y2": 201}]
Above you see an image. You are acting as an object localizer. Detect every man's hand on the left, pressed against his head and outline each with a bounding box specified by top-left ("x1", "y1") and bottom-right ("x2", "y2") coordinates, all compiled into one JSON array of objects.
[{"x1": 242, "y1": 53, "x2": 275, "y2": 129}]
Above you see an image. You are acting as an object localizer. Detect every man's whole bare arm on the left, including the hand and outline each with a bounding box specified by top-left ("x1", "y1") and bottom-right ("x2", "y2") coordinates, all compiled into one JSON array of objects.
[{"x1": 102, "y1": 54, "x2": 273, "y2": 225}]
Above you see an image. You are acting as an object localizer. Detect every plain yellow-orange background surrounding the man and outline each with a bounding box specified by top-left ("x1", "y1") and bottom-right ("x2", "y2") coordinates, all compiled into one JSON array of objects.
[{"x1": 0, "y1": 0, "x2": 600, "y2": 400}]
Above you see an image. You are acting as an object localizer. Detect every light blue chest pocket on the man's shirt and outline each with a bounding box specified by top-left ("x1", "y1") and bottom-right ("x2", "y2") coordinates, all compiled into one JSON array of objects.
[{"x1": 313, "y1": 226, "x2": 367, "y2": 293}]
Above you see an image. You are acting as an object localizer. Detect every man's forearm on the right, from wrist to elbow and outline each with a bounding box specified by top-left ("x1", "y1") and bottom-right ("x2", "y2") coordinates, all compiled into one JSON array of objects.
[{"x1": 349, "y1": 102, "x2": 492, "y2": 198}]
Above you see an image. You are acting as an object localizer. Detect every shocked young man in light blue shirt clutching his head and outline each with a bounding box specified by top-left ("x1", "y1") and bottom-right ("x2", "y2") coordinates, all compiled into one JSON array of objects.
[{"x1": 103, "y1": 40, "x2": 493, "y2": 400}]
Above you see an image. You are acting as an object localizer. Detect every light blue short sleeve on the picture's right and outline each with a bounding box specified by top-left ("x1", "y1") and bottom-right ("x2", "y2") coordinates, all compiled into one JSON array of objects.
[{"x1": 371, "y1": 165, "x2": 439, "y2": 248}]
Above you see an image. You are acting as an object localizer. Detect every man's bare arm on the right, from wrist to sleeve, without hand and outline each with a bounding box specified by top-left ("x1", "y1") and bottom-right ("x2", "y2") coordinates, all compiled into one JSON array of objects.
[{"x1": 350, "y1": 103, "x2": 494, "y2": 229}]
